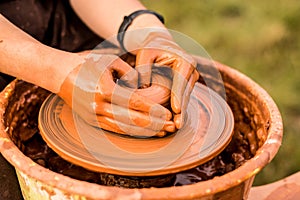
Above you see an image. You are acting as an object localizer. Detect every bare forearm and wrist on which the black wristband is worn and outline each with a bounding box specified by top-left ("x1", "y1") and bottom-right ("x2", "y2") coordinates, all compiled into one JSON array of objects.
[{"x1": 71, "y1": 0, "x2": 165, "y2": 45}]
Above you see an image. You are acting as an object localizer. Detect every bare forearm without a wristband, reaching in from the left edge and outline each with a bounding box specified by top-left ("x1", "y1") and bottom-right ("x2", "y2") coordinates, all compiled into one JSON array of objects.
[{"x1": 0, "y1": 15, "x2": 82, "y2": 93}]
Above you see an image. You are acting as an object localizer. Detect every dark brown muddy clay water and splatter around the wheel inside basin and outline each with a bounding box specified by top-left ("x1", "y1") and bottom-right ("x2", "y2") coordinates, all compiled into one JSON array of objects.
[{"x1": 4, "y1": 71, "x2": 268, "y2": 188}]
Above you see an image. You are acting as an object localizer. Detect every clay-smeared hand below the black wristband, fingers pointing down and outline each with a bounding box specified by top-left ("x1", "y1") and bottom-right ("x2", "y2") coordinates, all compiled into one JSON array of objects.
[{"x1": 136, "y1": 33, "x2": 199, "y2": 129}]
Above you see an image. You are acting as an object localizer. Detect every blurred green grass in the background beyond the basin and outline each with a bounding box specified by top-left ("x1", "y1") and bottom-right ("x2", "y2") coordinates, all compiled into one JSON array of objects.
[{"x1": 142, "y1": 0, "x2": 300, "y2": 185}]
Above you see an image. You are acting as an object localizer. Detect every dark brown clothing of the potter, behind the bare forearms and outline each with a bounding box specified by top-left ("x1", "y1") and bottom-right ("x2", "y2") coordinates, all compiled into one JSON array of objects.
[{"x1": 0, "y1": 0, "x2": 106, "y2": 200}]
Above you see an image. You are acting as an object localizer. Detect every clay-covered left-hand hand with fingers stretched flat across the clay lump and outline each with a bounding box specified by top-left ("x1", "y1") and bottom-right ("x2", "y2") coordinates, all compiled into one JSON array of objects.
[{"x1": 58, "y1": 53, "x2": 175, "y2": 137}]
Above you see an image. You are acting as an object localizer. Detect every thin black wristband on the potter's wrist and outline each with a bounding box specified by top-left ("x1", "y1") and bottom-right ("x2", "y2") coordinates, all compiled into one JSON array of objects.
[{"x1": 117, "y1": 10, "x2": 165, "y2": 51}]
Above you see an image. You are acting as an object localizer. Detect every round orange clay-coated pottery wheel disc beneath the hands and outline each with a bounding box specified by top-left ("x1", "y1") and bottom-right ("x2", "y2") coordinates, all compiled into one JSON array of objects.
[{"x1": 39, "y1": 83, "x2": 234, "y2": 176}]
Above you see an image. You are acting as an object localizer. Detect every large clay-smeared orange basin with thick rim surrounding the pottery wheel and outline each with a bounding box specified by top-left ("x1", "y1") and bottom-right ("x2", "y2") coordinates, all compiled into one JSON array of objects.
[{"x1": 0, "y1": 55, "x2": 282, "y2": 200}]
